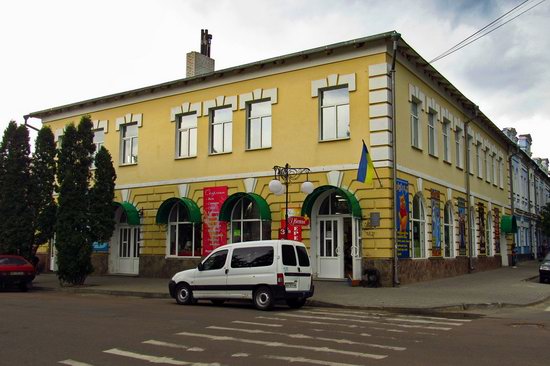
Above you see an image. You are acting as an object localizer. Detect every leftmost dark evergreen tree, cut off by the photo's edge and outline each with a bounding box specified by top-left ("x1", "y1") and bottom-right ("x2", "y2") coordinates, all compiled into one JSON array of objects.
[{"x1": 0, "y1": 126, "x2": 33, "y2": 259}]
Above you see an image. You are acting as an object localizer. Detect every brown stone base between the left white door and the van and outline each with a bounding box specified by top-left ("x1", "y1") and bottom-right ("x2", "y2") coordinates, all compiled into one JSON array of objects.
[{"x1": 139, "y1": 255, "x2": 201, "y2": 278}]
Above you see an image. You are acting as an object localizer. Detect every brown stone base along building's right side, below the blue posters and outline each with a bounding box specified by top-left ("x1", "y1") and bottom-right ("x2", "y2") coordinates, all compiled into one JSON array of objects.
[{"x1": 363, "y1": 256, "x2": 502, "y2": 287}]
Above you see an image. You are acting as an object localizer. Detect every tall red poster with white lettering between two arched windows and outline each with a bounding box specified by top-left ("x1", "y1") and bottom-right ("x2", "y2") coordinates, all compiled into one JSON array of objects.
[{"x1": 202, "y1": 186, "x2": 227, "y2": 256}]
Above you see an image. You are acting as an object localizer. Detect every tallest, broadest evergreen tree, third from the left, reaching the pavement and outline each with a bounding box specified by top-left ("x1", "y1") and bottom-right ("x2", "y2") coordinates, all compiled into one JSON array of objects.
[{"x1": 55, "y1": 116, "x2": 95, "y2": 285}]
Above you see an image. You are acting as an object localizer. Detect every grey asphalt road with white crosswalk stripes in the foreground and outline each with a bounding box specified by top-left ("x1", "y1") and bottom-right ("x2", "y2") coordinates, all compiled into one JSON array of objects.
[{"x1": 0, "y1": 292, "x2": 550, "y2": 366}]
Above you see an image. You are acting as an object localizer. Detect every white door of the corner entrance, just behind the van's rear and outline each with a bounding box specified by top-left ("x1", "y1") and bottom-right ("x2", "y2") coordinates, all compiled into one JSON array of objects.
[{"x1": 317, "y1": 217, "x2": 344, "y2": 278}]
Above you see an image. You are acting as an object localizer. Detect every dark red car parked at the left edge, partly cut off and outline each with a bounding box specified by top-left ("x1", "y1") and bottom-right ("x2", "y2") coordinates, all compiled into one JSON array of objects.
[{"x1": 0, "y1": 254, "x2": 36, "y2": 291}]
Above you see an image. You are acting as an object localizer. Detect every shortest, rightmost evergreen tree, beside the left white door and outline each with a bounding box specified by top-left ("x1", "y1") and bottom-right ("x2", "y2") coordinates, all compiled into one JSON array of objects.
[{"x1": 90, "y1": 146, "x2": 116, "y2": 243}]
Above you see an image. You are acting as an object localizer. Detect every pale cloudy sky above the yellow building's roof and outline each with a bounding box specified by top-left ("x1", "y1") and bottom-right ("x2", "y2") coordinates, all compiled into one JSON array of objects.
[{"x1": 0, "y1": 0, "x2": 550, "y2": 158}]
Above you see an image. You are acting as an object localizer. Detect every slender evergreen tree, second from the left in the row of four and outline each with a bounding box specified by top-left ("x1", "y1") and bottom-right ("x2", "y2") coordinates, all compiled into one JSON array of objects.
[{"x1": 31, "y1": 126, "x2": 57, "y2": 256}]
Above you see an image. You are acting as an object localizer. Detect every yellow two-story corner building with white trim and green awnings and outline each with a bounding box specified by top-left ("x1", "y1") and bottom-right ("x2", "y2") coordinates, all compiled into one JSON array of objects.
[{"x1": 30, "y1": 32, "x2": 510, "y2": 285}]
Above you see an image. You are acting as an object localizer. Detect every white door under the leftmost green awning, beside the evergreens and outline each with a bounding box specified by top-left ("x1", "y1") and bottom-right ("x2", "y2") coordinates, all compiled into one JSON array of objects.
[{"x1": 111, "y1": 225, "x2": 140, "y2": 274}]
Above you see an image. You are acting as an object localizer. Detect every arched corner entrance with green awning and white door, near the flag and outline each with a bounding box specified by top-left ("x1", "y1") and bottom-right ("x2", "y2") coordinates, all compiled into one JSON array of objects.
[{"x1": 302, "y1": 186, "x2": 363, "y2": 279}]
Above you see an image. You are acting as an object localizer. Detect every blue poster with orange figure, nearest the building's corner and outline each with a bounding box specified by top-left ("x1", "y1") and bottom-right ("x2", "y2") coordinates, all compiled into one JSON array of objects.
[{"x1": 395, "y1": 179, "x2": 410, "y2": 258}]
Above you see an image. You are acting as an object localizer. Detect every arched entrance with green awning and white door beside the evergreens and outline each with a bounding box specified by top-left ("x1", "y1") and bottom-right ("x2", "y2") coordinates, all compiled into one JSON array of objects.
[{"x1": 109, "y1": 202, "x2": 141, "y2": 274}]
